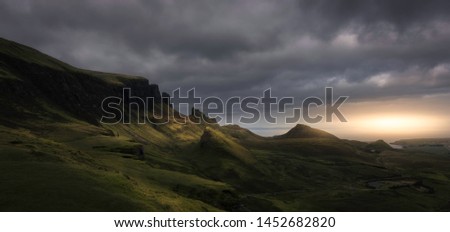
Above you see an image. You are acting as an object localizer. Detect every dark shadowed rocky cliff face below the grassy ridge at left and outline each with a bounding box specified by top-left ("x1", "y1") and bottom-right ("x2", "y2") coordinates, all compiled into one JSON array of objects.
[{"x1": 0, "y1": 41, "x2": 162, "y2": 127}]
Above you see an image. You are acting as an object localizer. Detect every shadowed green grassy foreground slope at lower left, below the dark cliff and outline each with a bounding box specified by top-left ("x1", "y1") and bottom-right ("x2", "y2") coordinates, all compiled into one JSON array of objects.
[{"x1": 0, "y1": 122, "x2": 227, "y2": 211}]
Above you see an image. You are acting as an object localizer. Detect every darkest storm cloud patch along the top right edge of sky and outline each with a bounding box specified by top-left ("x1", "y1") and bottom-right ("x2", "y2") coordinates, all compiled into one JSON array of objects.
[{"x1": 299, "y1": 0, "x2": 450, "y2": 34}]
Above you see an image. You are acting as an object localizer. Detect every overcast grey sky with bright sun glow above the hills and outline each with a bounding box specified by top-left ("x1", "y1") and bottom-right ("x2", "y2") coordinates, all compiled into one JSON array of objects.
[{"x1": 0, "y1": 0, "x2": 450, "y2": 140}]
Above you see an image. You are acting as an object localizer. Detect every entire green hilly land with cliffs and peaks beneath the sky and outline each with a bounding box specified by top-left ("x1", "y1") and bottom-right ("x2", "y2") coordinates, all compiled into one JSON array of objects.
[{"x1": 0, "y1": 39, "x2": 450, "y2": 211}]
